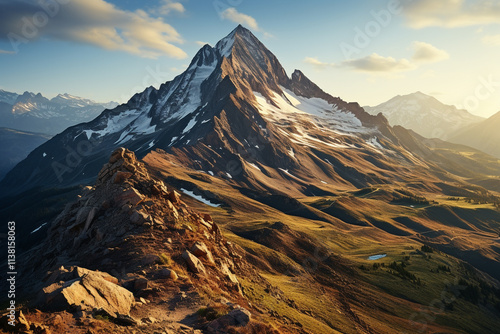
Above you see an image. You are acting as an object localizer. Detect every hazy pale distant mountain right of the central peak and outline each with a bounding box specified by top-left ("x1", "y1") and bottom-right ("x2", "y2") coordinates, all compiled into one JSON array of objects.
[{"x1": 364, "y1": 92, "x2": 484, "y2": 140}]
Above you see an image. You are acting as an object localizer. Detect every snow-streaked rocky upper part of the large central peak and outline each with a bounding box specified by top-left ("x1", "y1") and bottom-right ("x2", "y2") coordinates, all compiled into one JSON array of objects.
[{"x1": 1, "y1": 26, "x2": 398, "y2": 191}]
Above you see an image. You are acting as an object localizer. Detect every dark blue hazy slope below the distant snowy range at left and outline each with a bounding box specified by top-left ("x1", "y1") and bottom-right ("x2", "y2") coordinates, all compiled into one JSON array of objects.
[{"x1": 0, "y1": 128, "x2": 51, "y2": 180}]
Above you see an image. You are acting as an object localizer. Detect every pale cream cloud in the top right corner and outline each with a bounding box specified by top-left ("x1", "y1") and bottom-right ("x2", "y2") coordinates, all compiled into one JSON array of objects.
[{"x1": 403, "y1": 0, "x2": 500, "y2": 29}]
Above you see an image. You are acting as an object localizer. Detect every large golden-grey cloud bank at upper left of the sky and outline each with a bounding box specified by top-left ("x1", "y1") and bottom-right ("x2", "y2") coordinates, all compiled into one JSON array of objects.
[{"x1": 0, "y1": 0, "x2": 187, "y2": 59}]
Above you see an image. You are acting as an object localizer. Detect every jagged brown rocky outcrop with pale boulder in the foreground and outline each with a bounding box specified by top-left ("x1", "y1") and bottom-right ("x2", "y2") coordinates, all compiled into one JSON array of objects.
[{"x1": 2, "y1": 148, "x2": 294, "y2": 334}]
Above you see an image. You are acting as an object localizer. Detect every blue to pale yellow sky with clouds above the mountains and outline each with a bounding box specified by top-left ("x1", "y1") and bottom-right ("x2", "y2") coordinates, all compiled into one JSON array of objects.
[{"x1": 0, "y1": 0, "x2": 500, "y2": 117}]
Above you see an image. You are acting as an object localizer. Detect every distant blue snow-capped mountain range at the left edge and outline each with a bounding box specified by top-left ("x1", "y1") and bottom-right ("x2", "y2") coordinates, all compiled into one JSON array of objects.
[{"x1": 0, "y1": 90, "x2": 117, "y2": 135}]
